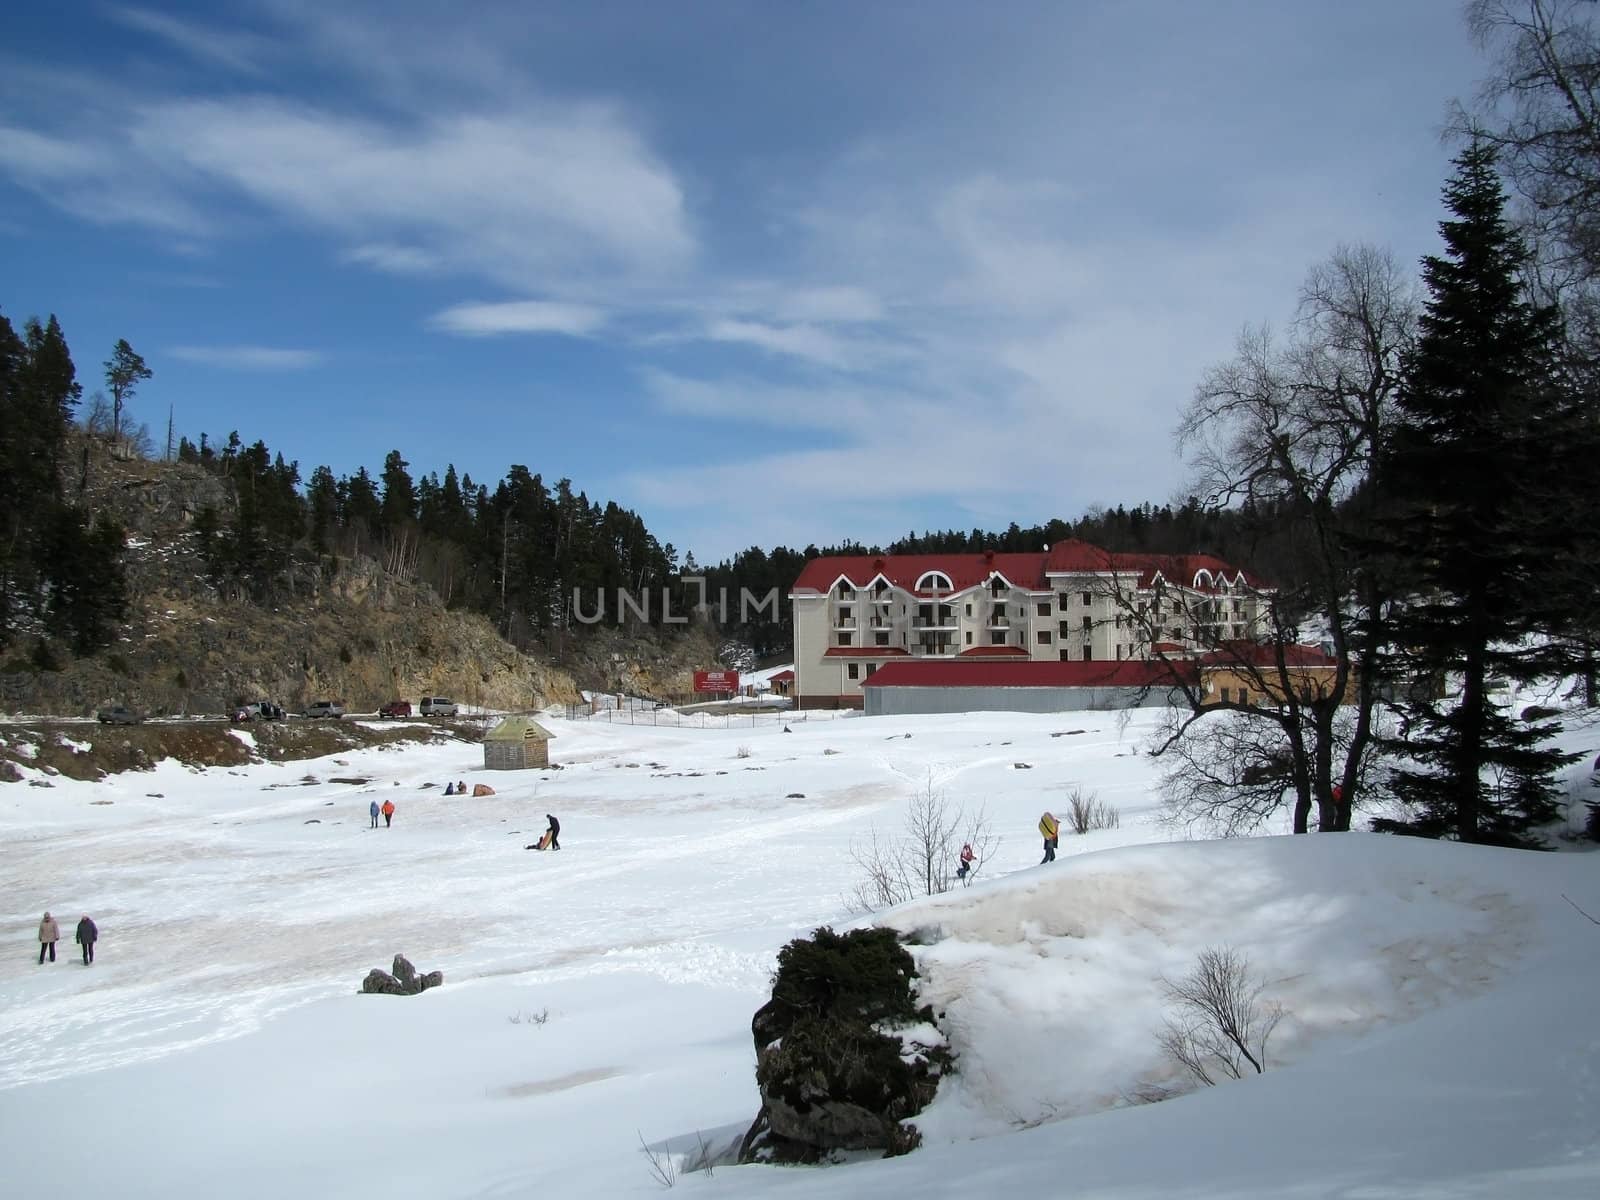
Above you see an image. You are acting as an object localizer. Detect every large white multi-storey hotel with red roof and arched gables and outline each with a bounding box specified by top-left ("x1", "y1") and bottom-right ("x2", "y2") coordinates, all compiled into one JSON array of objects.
[{"x1": 789, "y1": 541, "x2": 1272, "y2": 710}]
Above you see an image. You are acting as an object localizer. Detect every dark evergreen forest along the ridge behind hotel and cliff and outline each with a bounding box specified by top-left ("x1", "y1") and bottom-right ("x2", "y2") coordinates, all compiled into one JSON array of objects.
[{"x1": 0, "y1": 305, "x2": 1278, "y2": 672}]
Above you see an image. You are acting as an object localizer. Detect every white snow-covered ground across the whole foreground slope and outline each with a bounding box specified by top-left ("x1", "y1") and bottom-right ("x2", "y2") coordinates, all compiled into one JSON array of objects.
[{"x1": 0, "y1": 710, "x2": 1600, "y2": 1200}]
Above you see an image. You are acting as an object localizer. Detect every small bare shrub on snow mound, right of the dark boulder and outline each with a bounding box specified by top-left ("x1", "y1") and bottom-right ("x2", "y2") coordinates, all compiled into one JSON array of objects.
[{"x1": 1160, "y1": 946, "x2": 1283, "y2": 1086}]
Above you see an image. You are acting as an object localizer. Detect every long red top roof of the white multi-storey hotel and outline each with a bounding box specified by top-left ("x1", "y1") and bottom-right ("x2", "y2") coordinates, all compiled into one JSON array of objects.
[{"x1": 790, "y1": 539, "x2": 1264, "y2": 595}]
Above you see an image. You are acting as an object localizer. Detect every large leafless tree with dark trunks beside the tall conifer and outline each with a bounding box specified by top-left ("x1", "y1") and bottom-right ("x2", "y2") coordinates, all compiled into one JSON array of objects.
[{"x1": 1115, "y1": 246, "x2": 1418, "y2": 834}]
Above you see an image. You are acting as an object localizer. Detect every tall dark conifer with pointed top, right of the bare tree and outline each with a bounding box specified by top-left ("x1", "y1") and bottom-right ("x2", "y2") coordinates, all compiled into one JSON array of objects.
[{"x1": 1374, "y1": 146, "x2": 1581, "y2": 845}]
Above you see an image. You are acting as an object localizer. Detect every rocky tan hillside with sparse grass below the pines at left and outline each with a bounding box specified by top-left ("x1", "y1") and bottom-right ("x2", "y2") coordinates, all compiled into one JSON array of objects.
[{"x1": 0, "y1": 440, "x2": 715, "y2": 715}]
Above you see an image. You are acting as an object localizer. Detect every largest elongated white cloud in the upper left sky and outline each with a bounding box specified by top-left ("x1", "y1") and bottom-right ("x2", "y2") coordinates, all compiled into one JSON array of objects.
[{"x1": 130, "y1": 98, "x2": 694, "y2": 285}]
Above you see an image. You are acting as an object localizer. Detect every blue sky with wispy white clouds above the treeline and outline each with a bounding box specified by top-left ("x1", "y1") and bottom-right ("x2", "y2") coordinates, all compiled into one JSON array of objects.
[{"x1": 0, "y1": 0, "x2": 1485, "y2": 560}]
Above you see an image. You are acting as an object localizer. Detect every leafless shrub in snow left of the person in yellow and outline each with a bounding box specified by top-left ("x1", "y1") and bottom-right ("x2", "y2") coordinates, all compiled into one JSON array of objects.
[{"x1": 850, "y1": 776, "x2": 998, "y2": 912}]
